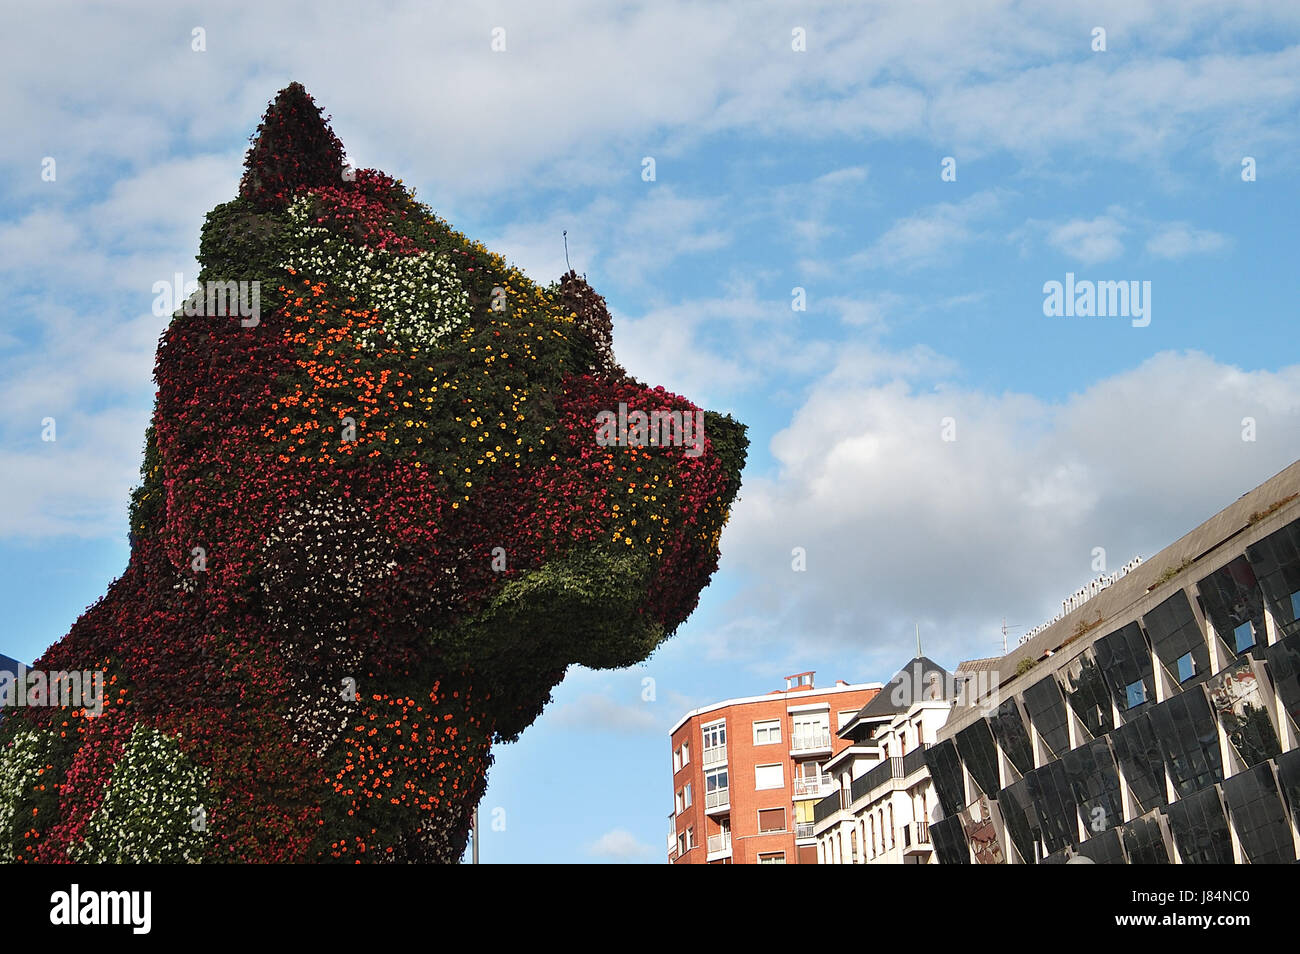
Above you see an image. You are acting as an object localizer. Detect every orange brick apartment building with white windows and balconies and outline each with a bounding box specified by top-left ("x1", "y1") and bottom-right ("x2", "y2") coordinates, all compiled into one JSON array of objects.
[{"x1": 668, "y1": 672, "x2": 881, "y2": 864}]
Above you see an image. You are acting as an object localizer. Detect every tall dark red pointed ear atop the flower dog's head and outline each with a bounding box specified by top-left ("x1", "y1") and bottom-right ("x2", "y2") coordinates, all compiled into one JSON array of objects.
[{"x1": 239, "y1": 83, "x2": 347, "y2": 208}]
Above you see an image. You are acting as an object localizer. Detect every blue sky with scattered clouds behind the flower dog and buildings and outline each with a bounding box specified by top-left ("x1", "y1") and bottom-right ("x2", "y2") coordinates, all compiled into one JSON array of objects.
[{"x1": 0, "y1": 0, "x2": 1300, "y2": 862}]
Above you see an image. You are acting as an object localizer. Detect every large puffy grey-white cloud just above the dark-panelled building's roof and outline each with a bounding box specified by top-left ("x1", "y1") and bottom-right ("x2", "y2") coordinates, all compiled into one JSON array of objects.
[{"x1": 709, "y1": 352, "x2": 1300, "y2": 660}]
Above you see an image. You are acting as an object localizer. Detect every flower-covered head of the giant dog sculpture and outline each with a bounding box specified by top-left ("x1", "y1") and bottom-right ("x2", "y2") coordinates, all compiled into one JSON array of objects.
[{"x1": 131, "y1": 84, "x2": 748, "y2": 737}]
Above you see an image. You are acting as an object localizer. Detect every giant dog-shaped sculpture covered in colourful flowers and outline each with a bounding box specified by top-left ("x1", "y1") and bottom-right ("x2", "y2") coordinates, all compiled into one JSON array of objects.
[{"x1": 0, "y1": 83, "x2": 748, "y2": 862}]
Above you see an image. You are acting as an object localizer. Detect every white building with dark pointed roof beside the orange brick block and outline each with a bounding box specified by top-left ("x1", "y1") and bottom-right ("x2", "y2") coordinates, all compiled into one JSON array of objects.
[{"x1": 813, "y1": 655, "x2": 965, "y2": 864}]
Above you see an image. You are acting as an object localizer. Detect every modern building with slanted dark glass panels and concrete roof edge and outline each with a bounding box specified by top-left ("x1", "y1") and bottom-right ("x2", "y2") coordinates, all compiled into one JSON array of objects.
[{"x1": 924, "y1": 461, "x2": 1300, "y2": 864}]
